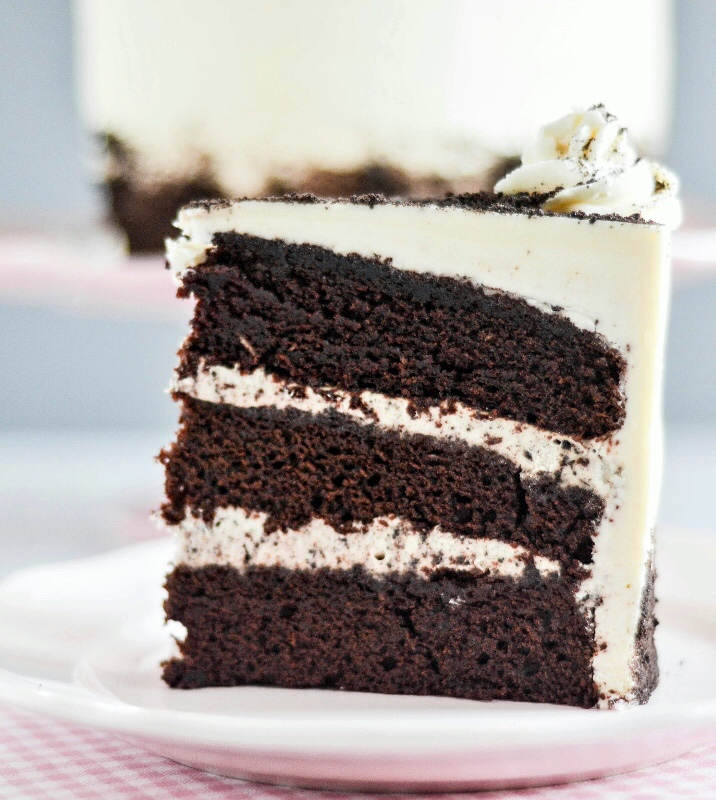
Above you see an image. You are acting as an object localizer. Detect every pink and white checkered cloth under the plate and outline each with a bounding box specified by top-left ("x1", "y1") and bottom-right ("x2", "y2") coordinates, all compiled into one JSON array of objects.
[{"x1": 0, "y1": 708, "x2": 716, "y2": 800}]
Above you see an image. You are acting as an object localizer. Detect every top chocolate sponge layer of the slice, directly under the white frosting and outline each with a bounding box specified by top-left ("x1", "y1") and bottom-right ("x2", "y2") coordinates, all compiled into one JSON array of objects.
[{"x1": 179, "y1": 233, "x2": 625, "y2": 438}]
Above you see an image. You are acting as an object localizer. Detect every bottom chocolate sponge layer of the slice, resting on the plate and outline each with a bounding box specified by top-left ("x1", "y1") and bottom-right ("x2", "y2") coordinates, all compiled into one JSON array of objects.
[{"x1": 164, "y1": 566, "x2": 597, "y2": 707}]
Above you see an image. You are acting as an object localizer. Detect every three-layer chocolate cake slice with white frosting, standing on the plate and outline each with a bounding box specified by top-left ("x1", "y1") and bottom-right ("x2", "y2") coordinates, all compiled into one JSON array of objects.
[{"x1": 161, "y1": 108, "x2": 678, "y2": 707}]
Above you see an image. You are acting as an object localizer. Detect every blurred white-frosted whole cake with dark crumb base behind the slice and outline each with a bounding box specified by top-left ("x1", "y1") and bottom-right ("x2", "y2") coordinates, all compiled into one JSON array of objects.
[{"x1": 76, "y1": 0, "x2": 672, "y2": 252}]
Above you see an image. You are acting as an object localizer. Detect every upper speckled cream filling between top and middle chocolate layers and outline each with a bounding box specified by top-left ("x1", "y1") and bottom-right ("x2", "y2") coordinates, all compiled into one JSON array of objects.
[{"x1": 172, "y1": 363, "x2": 621, "y2": 497}]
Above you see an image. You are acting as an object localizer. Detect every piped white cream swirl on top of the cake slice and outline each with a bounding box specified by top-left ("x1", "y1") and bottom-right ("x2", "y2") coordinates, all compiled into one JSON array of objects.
[{"x1": 495, "y1": 106, "x2": 681, "y2": 228}]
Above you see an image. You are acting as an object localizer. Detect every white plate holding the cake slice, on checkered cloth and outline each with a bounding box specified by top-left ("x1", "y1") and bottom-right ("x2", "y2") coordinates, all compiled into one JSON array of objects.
[{"x1": 0, "y1": 530, "x2": 716, "y2": 791}]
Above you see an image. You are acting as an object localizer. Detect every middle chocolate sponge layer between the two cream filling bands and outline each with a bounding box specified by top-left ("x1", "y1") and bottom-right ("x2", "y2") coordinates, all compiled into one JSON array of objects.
[{"x1": 160, "y1": 397, "x2": 604, "y2": 566}]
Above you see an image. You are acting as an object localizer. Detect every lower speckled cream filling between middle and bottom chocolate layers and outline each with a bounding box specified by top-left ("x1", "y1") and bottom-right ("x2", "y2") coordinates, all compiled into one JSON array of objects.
[{"x1": 166, "y1": 508, "x2": 560, "y2": 578}]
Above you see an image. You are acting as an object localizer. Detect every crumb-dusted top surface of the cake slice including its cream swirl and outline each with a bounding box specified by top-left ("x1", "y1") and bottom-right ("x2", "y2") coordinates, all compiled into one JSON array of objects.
[{"x1": 180, "y1": 105, "x2": 681, "y2": 229}]
